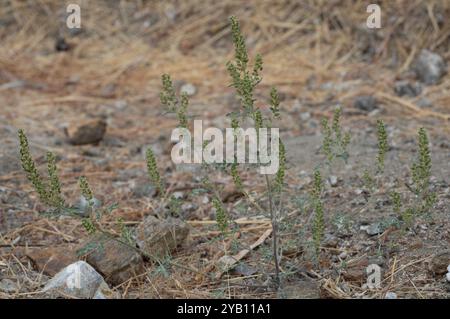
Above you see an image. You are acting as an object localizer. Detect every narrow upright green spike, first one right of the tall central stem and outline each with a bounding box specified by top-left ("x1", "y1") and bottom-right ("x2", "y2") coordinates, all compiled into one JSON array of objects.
[{"x1": 311, "y1": 169, "x2": 325, "y2": 256}]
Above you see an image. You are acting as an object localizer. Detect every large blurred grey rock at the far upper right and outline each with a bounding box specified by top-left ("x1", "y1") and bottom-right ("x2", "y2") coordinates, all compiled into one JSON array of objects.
[{"x1": 413, "y1": 50, "x2": 447, "y2": 85}]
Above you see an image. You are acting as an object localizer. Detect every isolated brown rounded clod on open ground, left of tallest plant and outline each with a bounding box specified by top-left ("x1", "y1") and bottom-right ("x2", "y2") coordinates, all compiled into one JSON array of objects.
[{"x1": 64, "y1": 119, "x2": 107, "y2": 145}]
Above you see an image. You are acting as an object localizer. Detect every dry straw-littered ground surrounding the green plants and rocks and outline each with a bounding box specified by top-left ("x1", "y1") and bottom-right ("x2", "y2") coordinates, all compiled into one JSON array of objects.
[{"x1": 0, "y1": 0, "x2": 450, "y2": 298}]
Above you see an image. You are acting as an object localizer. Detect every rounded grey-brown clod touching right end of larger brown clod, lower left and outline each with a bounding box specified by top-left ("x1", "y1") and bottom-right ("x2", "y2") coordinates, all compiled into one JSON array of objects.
[{"x1": 136, "y1": 216, "x2": 189, "y2": 257}]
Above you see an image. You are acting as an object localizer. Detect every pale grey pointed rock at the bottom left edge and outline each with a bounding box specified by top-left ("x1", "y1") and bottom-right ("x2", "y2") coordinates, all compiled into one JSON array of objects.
[{"x1": 42, "y1": 261, "x2": 112, "y2": 299}]
